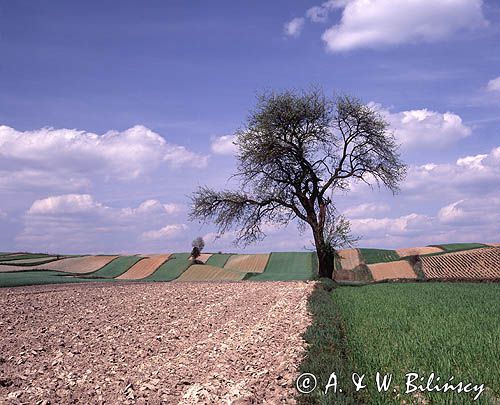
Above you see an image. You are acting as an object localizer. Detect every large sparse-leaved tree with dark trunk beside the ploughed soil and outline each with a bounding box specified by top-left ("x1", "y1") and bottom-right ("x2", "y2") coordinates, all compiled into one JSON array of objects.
[{"x1": 190, "y1": 89, "x2": 406, "y2": 278}]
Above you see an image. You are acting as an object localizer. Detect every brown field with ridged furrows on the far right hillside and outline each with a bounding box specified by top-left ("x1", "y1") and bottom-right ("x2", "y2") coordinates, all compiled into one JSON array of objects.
[{"x1": 422, "y1": 247, "x2": 500, "y2": 280}]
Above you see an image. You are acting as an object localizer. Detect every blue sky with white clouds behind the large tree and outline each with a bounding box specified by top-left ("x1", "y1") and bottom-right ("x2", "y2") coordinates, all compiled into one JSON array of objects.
[{"x1": 0, "y1": 0, "x2": 500, "y2": 253}]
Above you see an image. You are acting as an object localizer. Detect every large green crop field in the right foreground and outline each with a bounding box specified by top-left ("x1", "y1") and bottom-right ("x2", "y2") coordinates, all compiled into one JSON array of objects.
[{"x1": 301, "y1": 283, "x2": 500, "y2": 404}]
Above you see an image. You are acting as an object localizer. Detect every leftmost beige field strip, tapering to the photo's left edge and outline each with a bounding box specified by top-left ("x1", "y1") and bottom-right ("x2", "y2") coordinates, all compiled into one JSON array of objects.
[{"x1": 0, "y1": 256, "x2": 118, "y2": 274}]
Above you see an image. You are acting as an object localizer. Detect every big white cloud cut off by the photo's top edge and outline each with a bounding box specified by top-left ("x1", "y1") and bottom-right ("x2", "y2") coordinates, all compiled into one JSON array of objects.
[{"x1": 318, "y1": 0, "x2": 487, "y2": 52}]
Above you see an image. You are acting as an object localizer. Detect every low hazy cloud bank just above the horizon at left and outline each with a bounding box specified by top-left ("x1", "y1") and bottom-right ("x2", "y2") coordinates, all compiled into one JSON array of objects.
[{"x1": 16, "y1": 194, "x2": 187, "y2": 253}]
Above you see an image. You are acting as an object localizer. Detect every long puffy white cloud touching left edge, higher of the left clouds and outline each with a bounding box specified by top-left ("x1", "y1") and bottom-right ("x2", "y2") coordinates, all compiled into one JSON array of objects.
[{"x1": 0, "y1": 125, "x2": 208, "y2": 190}]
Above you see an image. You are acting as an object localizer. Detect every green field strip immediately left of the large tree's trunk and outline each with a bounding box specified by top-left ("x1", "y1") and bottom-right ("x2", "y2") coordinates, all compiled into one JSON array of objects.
[{"x1": 248, "y1": 252, "x2": 317, "y2": 281}]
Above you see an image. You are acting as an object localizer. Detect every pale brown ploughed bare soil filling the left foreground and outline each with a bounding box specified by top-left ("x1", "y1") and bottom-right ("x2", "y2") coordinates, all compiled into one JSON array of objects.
[{"x1": 0, "y1": 282, "x2": 314, "y2": 404}]
